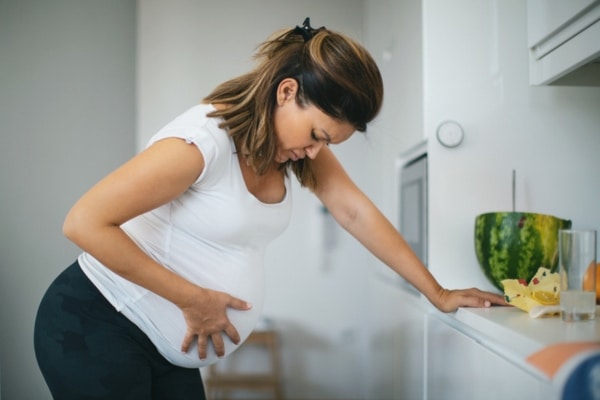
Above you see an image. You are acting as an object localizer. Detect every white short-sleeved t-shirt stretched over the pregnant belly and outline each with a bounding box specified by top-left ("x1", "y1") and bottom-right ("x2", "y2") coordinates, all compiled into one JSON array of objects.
[{"x1": 79, "y1": 105, "x2": 292, "y2": 368}]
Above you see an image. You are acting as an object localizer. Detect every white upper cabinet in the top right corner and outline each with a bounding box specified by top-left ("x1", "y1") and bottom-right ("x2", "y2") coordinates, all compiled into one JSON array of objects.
[{"x1": 527, "y1": 0, "x2": 600, "y2": 86}]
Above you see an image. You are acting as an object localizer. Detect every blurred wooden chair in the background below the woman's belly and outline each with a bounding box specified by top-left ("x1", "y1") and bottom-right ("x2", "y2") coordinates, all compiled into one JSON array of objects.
[{"x1": 204, "y1": 329, "x2": 283, "y2": 400}]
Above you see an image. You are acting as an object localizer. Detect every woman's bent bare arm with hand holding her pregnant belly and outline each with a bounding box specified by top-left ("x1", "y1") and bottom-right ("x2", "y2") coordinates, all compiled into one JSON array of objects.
[{"x1": 63, "y1": 138, "x2": 250, "y2": 358}]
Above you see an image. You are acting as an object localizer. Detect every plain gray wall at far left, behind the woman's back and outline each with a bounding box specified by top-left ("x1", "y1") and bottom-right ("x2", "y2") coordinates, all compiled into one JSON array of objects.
[{"x1": 0, "y1": 0, "x2": 136, "y2": 400}]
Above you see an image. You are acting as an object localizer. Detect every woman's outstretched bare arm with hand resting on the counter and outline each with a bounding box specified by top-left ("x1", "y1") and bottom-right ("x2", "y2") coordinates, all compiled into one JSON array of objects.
[{"x1": 314, "y1": 148, "x2": 506, "y2": 312}]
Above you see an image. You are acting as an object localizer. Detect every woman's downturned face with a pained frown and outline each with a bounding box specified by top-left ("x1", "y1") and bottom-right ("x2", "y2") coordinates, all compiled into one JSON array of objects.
[{"x1": 274, "y1": 80, "x2": 355, "y2": 163}]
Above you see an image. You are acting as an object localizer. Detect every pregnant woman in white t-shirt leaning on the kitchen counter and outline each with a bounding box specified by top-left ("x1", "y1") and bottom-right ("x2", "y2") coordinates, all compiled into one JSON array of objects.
[{"x1": 34, "y1": 19, "x2": 504, "y2": 400}]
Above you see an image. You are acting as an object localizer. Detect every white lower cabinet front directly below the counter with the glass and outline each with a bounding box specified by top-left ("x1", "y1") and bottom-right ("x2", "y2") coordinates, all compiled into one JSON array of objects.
[{"x1": 424, "y1": 315, "x2": 543, "y2": 400}]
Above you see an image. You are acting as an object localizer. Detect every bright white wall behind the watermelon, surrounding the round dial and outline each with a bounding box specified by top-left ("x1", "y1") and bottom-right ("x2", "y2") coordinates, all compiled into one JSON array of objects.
[{"x1": 423, "y1": 0, "x2": 600, "y2": 290}]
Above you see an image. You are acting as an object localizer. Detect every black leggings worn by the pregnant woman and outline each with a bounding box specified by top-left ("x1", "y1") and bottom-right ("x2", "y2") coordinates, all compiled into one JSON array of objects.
[{"x1": 34, "y1": 262, "x2": 205, "y2": 400}]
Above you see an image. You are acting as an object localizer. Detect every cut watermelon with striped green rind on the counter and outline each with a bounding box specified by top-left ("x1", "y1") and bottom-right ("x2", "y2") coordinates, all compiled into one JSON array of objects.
[{"x1": 475, "y1": 212, "x2": 571, "y2": 291}]
